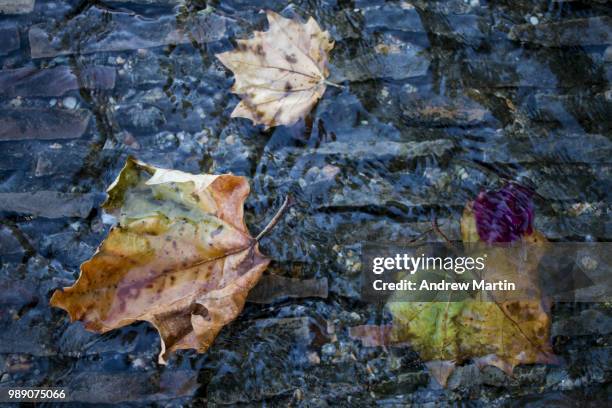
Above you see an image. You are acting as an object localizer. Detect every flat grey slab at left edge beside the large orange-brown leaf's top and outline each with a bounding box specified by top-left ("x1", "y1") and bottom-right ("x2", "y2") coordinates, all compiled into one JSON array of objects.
[{"x1": 0, "y1": 191, "x2": 96, "y2": 218}]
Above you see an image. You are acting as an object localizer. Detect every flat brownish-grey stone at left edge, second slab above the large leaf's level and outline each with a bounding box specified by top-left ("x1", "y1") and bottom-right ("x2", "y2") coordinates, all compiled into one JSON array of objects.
[{"x1": 0, "y1": 108, "x2": 91, "y2": 141}]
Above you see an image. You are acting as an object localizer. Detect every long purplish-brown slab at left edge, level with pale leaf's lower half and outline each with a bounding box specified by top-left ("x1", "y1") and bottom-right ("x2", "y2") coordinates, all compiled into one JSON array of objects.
[{"x1": 0, "y1": 66, "x2": 115, "y2": 96}]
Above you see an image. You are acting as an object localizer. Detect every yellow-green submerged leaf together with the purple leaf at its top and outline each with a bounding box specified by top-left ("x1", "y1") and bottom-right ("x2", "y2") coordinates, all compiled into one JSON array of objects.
[{"x1": 351, "y1": 187, "x2": 556, "y2": 386}]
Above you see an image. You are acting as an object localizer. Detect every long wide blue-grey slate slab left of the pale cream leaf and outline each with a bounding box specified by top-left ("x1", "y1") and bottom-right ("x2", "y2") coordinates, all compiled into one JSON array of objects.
[{"x1": 29, "y1": 7, "x2": 225, "y2": 58}]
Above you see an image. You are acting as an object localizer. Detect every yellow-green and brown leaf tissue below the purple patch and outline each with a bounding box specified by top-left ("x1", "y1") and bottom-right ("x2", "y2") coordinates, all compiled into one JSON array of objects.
[{"x1": 350, "y1": 203, "x2": 558, "y2": 386}]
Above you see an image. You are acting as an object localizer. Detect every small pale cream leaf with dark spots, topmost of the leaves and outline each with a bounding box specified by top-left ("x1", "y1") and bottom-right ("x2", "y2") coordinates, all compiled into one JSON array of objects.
[{"x1": 217, "y1": 11, "x2": 334, "y2": 128}]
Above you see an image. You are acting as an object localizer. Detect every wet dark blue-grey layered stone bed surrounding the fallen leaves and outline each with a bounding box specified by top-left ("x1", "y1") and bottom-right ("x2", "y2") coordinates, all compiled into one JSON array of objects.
[{"x1": 0, "y1": 0, "x2": 612, "y2": 407}]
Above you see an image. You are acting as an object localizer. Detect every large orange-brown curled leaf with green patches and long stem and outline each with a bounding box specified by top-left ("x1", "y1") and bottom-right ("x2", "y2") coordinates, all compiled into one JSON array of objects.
[{"x1": 51, "y1": 158, "x2": 269, "y2": 364}]
